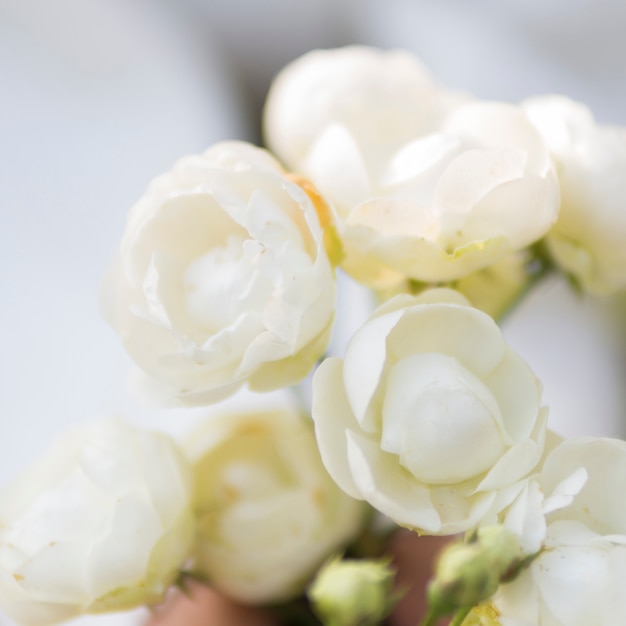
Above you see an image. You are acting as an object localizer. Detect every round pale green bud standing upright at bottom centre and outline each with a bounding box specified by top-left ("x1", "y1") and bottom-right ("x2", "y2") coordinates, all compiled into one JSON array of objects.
[{"x1": 308, "y1": 558, "x2": 400, "y2": 626}]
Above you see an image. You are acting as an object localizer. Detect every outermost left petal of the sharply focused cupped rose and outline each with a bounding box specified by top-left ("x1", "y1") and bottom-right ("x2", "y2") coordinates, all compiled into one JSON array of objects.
[{"x1": 311, "y1": 358, "x2": 363, "y2": 500}]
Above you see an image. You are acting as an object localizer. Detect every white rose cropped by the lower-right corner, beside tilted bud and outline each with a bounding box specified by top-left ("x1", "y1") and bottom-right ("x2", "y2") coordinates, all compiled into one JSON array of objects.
[{"x1": 494, "y1": 438, "x2": 626, "y2": 626}]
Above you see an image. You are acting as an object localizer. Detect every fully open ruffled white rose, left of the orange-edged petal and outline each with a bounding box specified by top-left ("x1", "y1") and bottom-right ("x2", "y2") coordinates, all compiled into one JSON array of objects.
[{"x1": 104, "y1": 142, "x2": 335, "y2": 404}]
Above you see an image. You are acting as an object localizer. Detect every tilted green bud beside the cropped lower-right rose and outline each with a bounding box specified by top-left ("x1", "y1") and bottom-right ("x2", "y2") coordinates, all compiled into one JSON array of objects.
[{"x1": 428, "y1": 526, "x2": 524, "y2": 615}]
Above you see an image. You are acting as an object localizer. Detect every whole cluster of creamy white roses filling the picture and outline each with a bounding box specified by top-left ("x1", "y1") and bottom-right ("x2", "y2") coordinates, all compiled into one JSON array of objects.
[{"x1": 0, "y1": 47, "x2": 626, "y2": 626}]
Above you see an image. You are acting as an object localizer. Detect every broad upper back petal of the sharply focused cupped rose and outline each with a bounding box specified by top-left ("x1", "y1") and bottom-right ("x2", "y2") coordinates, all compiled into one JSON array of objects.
[{"x1": 387, "y1": 304, "x2": 506, "y2": 378}]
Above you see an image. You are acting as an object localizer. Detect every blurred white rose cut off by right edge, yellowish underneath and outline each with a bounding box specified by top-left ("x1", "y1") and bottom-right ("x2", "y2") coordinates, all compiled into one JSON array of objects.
[{"x1": 524, "y1": 96, "x2": 626, "y2": 294}]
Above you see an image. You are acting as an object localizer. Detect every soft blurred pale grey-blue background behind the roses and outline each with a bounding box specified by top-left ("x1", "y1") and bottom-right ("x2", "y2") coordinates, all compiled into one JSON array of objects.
[{"x1": 0, "y1": 0, "x2": 626, "y2": 626}]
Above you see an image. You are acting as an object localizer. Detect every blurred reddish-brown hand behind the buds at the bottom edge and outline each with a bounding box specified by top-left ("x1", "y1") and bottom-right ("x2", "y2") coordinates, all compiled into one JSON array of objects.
[{"x1": 147, "y1": 529, "x2": 450, "y2": 626}]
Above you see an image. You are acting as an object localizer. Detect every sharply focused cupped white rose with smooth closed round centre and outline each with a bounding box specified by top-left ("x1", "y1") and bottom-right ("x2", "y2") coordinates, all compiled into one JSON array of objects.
[{"x1": 313, "y1": 289, "x2": 547, "y2": 535}]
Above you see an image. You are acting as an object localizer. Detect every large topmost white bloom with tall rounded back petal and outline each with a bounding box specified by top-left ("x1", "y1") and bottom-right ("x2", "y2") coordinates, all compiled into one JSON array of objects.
[{"x1": 266, "y1": 48, "x2": 559, "y2": 289}]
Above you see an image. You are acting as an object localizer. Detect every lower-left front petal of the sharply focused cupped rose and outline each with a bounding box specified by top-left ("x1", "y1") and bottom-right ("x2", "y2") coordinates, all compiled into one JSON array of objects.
[{"x1": 347, "y1": 431, "x2": 441, "y2": 534}]
